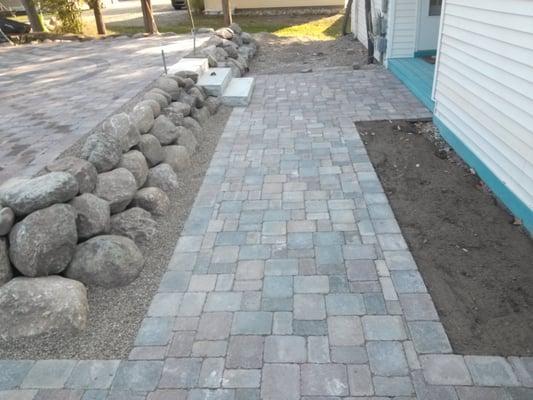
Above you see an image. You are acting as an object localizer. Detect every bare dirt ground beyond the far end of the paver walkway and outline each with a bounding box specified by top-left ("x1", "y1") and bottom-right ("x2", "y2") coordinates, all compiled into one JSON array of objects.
[{"x1": 250, "y1": 33, "x2": 375, "y2": 75}]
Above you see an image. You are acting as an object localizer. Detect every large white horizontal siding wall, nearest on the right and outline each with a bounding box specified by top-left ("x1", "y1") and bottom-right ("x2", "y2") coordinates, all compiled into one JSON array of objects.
[{"x1": 434, "y1": 0, "x2": 533, "y2": 209}]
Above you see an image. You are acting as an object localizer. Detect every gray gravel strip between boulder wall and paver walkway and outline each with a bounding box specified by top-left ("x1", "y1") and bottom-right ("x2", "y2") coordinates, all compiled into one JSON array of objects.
[{"x1": 0, "y1": 106, "x2": 231, "y2": 359}]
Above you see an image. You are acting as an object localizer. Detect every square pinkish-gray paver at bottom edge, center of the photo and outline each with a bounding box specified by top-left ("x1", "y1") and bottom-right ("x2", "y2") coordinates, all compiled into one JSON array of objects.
[{"x1": 261, "y1": 364, "x2": 300, "y2": 400}]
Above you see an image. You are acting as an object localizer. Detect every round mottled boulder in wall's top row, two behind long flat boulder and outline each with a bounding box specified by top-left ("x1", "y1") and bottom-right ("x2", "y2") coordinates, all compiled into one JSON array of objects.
[{"x1": 81, "y1": 132, "x2": 122, "y2": 172}]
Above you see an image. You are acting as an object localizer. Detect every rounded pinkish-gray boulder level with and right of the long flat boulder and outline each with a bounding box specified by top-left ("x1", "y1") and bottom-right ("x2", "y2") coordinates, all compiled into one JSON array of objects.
[{"x1": 94, "y1": 168, "x2": 137, "y2": 214}]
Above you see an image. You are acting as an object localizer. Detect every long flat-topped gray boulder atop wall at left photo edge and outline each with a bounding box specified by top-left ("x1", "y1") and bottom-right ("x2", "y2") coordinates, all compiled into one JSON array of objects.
[{"x1": 0, "y1": 172, "x2": 79, "y2": 216}]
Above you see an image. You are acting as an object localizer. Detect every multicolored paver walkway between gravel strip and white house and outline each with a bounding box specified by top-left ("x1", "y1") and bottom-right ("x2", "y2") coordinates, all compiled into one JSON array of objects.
[{"x1": 0, "y1": 70, "x2": 533, "y2": 400}]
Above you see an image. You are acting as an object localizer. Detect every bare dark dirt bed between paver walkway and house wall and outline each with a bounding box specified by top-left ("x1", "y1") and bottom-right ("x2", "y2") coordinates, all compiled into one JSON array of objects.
[{"x1": 357, "y1": 121, "x2": 533, "y2": 356}]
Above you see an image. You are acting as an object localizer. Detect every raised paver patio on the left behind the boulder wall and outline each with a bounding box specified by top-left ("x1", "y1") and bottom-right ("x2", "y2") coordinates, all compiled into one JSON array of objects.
[{"x1": 0, "y1": 36, "x2": 205, "y2": 184}]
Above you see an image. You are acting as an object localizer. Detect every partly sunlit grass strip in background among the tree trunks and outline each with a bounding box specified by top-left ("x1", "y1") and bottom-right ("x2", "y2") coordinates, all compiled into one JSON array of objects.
[{"x1": 105, "y1": 14, "x2": 343, "y2": 40}]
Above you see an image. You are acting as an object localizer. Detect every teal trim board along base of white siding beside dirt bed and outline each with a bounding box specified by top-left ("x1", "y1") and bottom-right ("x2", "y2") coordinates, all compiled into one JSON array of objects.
[{"x1": 433, "y1": 116, "x2": 533, "y2": 235}]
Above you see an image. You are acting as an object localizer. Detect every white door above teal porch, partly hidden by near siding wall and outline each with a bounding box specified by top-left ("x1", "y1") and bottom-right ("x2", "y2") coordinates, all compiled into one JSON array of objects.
[{"x1": 416, "y1": 0, "x2": 442, "y2": 51}]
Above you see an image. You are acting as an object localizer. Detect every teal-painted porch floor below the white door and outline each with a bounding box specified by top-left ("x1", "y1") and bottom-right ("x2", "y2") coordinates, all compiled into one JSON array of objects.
[{"x1": 388, "y1": 58, "x2": 435, "y2": 112}]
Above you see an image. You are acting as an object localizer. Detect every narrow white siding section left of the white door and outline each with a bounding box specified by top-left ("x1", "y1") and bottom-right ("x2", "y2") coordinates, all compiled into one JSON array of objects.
[{"x1": 387, "y1": 0, "x2": 418, "y2": 58}]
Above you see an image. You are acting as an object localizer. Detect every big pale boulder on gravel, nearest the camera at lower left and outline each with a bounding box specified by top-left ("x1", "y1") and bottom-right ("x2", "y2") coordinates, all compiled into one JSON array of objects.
[{"x1": 0, "y1": 276, "x2": 89, "y2": 340}]
